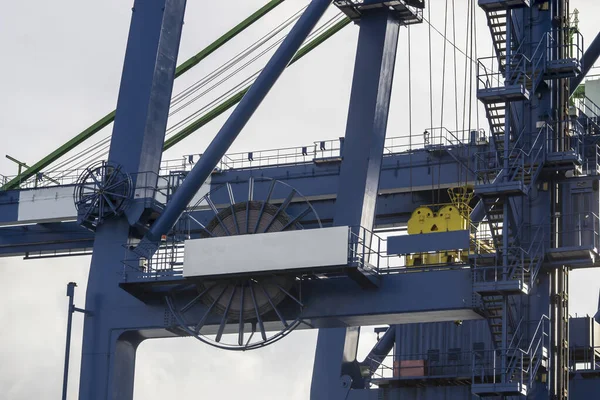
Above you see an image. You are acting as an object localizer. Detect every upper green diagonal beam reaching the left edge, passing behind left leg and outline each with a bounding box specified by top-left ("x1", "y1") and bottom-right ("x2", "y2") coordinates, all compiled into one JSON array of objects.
[{"x1": 0, "y1": 0, "x2": 284, "y2": 190}]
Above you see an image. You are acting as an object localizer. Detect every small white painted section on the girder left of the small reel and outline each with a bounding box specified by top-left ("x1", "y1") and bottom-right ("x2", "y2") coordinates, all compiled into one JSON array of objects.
[{"x1": 18, "y1": 186, "x2": 77, "y2": 222}]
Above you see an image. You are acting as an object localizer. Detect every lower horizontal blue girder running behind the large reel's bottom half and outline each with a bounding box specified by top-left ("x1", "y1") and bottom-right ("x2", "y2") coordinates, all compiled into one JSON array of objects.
[{"x1": 118, "y1": 268, "x2": 481, "y2": 328}]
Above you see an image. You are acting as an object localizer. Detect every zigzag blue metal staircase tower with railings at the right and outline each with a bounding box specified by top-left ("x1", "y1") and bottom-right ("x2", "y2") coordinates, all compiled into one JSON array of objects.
[{"x1": 472, "y1": 0, "x2": 552, "y2": 398}]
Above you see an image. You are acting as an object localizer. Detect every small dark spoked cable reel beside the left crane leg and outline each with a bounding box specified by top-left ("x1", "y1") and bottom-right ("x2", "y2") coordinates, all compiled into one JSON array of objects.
[{"x1": 73, "y1": 161, "x2": 133, "y2": 229}]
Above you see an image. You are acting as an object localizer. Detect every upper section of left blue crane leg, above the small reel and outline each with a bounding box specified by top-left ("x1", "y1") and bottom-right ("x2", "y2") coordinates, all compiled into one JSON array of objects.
[{"x1": 109, "y1": 0, "x2": 186, "y2": 225}]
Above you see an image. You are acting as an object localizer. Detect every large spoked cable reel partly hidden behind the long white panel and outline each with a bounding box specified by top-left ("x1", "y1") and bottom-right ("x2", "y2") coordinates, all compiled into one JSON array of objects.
[{"x1": 166, "y1": 179, "x2": 321, "y2": 350}]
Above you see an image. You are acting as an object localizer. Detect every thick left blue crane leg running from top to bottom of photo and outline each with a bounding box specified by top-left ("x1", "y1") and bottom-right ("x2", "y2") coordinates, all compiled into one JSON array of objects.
[{"x1": 79, "y1": 0, "x2": 186, "y2": 400}]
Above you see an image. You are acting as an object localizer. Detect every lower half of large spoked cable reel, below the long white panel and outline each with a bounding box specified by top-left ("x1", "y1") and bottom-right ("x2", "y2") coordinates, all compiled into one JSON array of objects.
[{"x1": 166, "y1": 275, "x2": 303, "y2": 350}]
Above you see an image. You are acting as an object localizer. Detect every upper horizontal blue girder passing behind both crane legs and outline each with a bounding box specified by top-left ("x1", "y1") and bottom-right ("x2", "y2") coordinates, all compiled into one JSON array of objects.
[{"x1": 0, "y1": 146, "x2": 482, "y2": 228}]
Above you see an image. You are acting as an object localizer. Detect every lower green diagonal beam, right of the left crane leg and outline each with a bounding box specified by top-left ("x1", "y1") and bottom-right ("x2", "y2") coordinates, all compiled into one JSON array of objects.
[{"x1": 163, "y1": 18, "x2": 350, "y2": 151}]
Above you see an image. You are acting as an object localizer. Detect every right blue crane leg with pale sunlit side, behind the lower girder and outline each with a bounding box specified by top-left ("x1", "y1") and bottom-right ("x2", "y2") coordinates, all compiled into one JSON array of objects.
[{"x1": 311, "y1": 9, "x2": 400, "y2": 400}]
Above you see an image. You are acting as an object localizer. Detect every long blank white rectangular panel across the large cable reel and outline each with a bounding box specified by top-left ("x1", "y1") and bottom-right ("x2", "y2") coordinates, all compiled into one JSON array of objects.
[{"x1": 183, "y1": 226, "x2": 348, "y2": 277}]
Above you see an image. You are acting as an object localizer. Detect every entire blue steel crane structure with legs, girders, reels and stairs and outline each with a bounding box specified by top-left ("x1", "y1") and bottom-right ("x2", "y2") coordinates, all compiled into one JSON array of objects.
[{"x1": 0, "y1": 0, "x2": 600, "y2": 400}]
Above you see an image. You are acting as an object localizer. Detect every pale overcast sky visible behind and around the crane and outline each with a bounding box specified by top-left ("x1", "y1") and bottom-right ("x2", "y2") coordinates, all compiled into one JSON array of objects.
[{"x1": 0, "y1": 0, "x2": 600, "y2": 400}]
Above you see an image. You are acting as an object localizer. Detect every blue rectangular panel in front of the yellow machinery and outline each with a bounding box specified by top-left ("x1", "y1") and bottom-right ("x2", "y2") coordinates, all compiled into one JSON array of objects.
[{"x1": 387, "y1": 230, "x2": 470, "y2": 254}]
